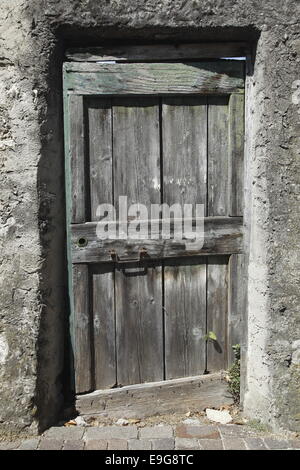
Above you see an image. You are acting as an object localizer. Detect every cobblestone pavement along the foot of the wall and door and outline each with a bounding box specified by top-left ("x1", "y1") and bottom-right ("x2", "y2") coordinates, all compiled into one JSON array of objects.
[{"x1": 0, "y1": 422, "x2": 300, "y2": 451}]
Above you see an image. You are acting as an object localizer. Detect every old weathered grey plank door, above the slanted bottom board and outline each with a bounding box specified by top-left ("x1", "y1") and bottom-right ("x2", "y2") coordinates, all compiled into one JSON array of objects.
[{"x1": 64, "y1": 60, "x2": 244, "y2": 393}]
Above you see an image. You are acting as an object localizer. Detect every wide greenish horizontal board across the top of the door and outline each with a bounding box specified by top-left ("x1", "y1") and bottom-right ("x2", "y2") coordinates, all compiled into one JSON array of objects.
[{"x1": 64, "y1": 60, "x2": 244, "y2": 95}]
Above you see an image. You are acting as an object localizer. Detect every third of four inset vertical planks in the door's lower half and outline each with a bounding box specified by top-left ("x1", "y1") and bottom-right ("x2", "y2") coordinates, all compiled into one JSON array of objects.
[{"x1": 164, "y1": 258, "x2": 206, "y2": 379}]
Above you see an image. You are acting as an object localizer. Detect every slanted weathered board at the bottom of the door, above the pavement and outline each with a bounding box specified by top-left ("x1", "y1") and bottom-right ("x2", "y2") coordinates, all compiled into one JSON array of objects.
[{"x1": 76, "y1": 373, "x2": 233, "y2": 419}]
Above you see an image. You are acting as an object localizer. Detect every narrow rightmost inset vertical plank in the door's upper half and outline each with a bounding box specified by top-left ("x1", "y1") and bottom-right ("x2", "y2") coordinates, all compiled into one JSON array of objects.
[{"x1": 207, "y1": 96, "x2": 228, "y2": 216}]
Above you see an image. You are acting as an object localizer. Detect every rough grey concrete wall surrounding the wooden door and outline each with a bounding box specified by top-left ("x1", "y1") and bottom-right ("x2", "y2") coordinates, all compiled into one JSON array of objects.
[{"x1": 0, "y1": 0, "x2": 300, "y2": 430}]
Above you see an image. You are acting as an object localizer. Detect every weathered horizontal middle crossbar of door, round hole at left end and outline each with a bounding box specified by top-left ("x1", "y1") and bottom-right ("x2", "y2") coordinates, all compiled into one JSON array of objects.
[{"x1": 71, "y1": 217, "x2": 243, "y2": 263}]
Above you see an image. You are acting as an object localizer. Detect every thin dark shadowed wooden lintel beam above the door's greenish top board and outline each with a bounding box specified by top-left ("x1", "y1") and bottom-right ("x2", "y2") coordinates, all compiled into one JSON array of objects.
[{"x1": 66, "y1": 42, "x2": 249, "y2": 62}]
